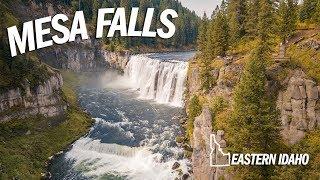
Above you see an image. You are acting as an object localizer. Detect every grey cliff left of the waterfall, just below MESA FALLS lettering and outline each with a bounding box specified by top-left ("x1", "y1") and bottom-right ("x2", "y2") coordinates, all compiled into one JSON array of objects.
[{"x1": 39, "y1": 39, "x2": 130, "y2": 72}]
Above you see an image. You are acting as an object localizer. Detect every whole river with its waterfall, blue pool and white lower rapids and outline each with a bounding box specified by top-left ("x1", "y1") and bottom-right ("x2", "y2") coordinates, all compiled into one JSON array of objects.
[{"x1": 49, "y1": 52, "x2": 194, "y2": 179}]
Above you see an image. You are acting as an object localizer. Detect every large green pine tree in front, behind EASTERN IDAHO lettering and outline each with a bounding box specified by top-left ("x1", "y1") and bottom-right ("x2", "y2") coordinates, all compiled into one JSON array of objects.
[{"x1": 229, "y1": 42, "x2": 281, "y2": 179}]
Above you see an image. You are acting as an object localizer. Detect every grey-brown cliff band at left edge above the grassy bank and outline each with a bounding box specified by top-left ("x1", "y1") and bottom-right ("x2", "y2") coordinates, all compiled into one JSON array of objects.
[{"x1": 0, "y1": 73, "x2": 67, "y2": 122}]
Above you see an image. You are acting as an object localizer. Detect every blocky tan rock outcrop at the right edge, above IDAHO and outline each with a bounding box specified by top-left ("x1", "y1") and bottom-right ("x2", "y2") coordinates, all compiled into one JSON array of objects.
[{"x1": 277, "y1": 70, "x2": 320, "y2": 144}]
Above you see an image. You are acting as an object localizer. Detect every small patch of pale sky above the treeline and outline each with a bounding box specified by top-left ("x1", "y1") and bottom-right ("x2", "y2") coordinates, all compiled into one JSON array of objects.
[{"x1": 180, "y1": 0, "x2": 221, "y2": 17}]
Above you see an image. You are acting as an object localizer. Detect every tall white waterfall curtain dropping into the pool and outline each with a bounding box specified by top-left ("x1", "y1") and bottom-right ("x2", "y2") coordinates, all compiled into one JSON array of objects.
[{"x1": 124, "y1": 55, "x2": 188, "y2": 107}]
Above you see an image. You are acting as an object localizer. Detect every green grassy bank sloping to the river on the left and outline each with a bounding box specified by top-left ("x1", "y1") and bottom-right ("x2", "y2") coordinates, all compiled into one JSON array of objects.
[{"x1": 0, "y1": 72, "x2": 92, "y2": 179}]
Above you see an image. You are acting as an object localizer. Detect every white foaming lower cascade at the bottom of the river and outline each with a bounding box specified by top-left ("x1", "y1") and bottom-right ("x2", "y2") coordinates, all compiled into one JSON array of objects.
[{"x1": 66, "y1": 137, "x2": 188, "y2": 180}]
